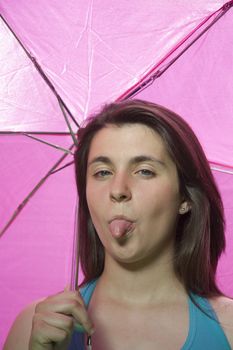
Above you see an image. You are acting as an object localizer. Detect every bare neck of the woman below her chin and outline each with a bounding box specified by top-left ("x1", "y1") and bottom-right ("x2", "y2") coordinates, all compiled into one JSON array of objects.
[{"x1": 100, "y1": 249, "x2": 186, "y2": 303}]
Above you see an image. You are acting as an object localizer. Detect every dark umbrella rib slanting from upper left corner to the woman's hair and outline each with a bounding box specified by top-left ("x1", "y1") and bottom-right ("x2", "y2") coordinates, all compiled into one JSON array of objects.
[{"x1": 0, "y1": 15, "x2": 79, "y2": 128}]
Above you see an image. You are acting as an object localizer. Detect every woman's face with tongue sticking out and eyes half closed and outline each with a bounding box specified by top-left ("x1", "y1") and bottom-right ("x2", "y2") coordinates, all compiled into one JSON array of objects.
[{"x1": 86, "y1": 124, "x2": 184, "y2": 263}]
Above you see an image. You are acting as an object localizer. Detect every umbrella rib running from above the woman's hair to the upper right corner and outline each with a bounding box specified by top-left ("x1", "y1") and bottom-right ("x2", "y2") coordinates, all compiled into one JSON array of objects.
[{"x1": 120, "y1": 0, "x2": 233, "y2": 100}]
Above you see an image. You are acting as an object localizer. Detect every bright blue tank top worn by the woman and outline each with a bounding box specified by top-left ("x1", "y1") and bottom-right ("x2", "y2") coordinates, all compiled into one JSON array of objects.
[{"x1": 68, "y1": 280, "x2": 231, "y2": 350}]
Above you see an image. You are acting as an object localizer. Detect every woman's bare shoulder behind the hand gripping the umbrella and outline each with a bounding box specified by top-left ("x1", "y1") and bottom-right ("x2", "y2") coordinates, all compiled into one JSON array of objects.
[{"x1": 3, "y1": 300, "x2": 39, "y2": 350}]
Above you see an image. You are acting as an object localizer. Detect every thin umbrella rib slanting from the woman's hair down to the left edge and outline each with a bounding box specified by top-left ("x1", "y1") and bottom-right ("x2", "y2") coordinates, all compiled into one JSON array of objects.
[{"x1": 0, "y1": 144, "x2": 74, "y2": 238}]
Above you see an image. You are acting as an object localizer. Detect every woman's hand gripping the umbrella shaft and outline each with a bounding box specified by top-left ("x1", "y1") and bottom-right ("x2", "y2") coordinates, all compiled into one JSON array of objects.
[{"x1": 29, "y1": 290, "x2": 93, "y2": 350}]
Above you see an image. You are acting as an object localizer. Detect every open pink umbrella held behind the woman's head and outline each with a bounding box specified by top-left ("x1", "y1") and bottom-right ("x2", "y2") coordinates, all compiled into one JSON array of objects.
[{"x1": 0, "y1": 0, "x2": 233, "y2": 345}]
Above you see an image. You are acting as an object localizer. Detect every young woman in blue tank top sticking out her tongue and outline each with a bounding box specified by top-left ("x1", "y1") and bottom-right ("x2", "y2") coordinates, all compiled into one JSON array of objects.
[{"x1": 4, "y1": 100, "x2": 233, "y2": 350}]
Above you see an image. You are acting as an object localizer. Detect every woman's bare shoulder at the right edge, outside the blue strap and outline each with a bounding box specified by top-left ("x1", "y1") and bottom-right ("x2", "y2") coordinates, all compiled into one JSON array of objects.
[{"x1": 210, "y1": 296, "x2": 233, "y2": 348}]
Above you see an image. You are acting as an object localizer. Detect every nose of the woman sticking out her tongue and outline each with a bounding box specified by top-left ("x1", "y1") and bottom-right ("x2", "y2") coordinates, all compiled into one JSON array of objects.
[{"x1": 110, "y1": 174, "x2": 132, "y2": 203}]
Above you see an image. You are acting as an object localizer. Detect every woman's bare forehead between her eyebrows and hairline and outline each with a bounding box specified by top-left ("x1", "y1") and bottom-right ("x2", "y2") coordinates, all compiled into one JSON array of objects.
[{"x1": 88, "y1": 123, "x2": 171, "y2": 161}]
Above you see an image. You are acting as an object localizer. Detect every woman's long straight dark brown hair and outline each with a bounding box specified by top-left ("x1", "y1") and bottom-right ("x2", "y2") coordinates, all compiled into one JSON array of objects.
[{"x1": 75, "y1": 100, "x2": 225, "y2": 297}]
